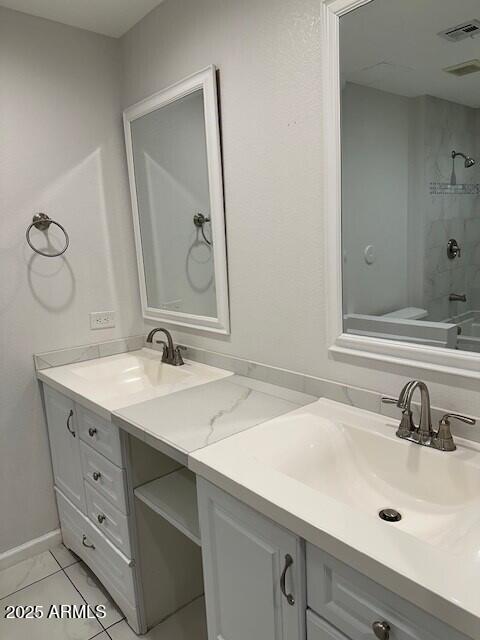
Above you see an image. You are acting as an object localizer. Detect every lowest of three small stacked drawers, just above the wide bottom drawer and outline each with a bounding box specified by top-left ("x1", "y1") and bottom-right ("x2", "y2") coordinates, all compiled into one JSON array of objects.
[{"x1": 85, "y1": 483, "x2": 130, "y2": 557}]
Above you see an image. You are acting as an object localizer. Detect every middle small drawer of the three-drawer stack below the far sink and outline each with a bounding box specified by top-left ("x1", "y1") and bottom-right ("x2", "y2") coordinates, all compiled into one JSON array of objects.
[{"x1": 80, "y1": 442, "x2": 127, "y2": 513}]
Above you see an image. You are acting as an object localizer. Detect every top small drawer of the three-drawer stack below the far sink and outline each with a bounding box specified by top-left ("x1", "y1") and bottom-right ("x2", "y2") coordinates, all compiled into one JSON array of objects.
[{"x1": 77, "y1": 404, "x2": 123, "y2": 467}]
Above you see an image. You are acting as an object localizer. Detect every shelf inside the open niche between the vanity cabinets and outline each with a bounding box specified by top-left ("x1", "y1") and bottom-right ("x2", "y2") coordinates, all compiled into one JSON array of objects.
[{"x1": 134, "y1": 467, "x2": 202, "y2": 546}]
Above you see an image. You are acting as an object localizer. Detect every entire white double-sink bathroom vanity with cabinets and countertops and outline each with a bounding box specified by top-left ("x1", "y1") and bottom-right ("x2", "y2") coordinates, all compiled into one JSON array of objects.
[{"x1": 37, "y1": 349, "x2": 480, "y2": 640}]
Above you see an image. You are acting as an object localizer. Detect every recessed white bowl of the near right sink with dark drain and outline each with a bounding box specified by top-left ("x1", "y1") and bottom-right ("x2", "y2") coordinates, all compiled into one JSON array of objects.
[{"x1": 249, "y1": 403, "x2": 480, "y2": 553}]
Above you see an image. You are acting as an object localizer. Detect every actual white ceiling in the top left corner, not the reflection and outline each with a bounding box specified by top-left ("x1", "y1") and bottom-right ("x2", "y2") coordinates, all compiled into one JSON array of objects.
[{"x1": 0, "y1": 0, "x2": 163, "y2": 38}]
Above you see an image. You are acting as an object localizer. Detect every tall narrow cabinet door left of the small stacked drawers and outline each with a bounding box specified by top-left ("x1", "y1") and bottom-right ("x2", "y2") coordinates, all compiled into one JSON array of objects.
[{"x1": 44, "y1": 386, "x2": 86, "y2": 513}]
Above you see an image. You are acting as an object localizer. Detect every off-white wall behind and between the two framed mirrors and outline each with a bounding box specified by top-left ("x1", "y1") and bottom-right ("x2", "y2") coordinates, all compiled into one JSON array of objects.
[{"x1": 122, "y1": 0, "x2": 480, "y2": 415}]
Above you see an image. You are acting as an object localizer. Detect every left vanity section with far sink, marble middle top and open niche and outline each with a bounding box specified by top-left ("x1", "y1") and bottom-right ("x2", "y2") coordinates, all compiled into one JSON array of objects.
[{"x1": 37, "y1": 349, "x2": 314, "y2": 633}]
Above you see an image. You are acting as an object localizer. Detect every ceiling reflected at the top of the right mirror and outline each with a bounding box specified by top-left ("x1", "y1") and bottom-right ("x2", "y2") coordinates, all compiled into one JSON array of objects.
[{"x1": 340, "y1": 0, "x2": 480, "y2": 107}]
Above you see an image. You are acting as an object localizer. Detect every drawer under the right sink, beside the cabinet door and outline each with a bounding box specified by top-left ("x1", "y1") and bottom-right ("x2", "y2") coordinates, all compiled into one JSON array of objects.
[{"x1": 307, "y1": 544, "x2": 466, "y2": 640}]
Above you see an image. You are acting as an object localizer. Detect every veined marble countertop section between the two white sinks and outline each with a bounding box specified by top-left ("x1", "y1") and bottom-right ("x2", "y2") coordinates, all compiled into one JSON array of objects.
[{"x1": 112, "y1": 375, "x2": 317, "y2": 466}]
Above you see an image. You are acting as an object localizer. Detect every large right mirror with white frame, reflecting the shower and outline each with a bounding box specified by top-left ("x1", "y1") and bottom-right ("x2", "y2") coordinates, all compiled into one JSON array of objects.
[{"x1": 323, "y1": 0, "x2": 480, "y2": 377}]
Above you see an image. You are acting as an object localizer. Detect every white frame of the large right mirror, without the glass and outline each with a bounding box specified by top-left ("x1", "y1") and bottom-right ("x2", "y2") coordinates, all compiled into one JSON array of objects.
[{"x1": 321, "y1": 0, "x2": 480, "y2": 379}]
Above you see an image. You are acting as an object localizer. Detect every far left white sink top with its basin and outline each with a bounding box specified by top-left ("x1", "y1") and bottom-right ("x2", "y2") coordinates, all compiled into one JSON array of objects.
[{"x1": 39, "y1": 349, "x2": 232, "y2": 415}]
